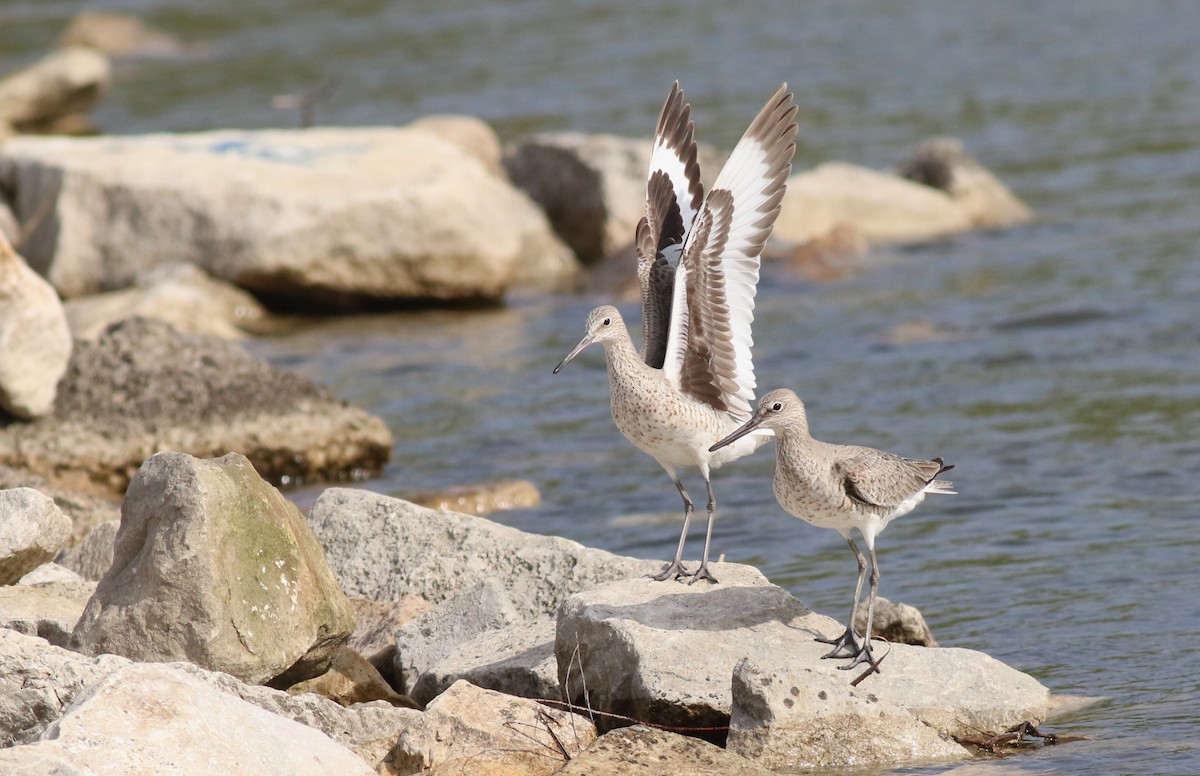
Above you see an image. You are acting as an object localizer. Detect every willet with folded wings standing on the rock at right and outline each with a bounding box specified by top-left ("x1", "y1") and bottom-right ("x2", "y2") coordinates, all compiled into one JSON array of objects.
[{"x1": 712, "y1": 389, "x2": 954, "y2": 668}]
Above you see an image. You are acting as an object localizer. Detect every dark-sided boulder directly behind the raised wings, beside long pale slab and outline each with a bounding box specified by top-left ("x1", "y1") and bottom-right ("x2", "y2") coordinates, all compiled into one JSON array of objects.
[{"x1": 504, "y1": 133, "x2": 722, "y2": 264}]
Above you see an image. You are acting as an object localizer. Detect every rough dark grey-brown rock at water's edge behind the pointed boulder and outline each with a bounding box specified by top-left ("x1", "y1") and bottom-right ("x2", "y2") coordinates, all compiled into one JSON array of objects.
[{"x1": 0, "y1": 318, "x2": 391, "y2": 495}]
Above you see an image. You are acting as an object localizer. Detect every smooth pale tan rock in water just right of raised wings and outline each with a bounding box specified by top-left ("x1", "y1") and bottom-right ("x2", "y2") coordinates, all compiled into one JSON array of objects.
[{"x1": 773, "y1": 162, "x2": 972, "y2": 243}]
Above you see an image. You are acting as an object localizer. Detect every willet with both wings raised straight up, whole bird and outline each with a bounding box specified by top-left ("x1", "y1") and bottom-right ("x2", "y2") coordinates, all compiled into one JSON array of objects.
[{"x1": 554, "y1": 82, "x2": 796, "y2": 584}]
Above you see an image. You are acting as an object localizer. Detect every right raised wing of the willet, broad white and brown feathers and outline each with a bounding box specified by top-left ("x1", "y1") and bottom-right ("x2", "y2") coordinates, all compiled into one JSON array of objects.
[{"x1": 664, "y1": 84, "x2": 796, "y2": 420}]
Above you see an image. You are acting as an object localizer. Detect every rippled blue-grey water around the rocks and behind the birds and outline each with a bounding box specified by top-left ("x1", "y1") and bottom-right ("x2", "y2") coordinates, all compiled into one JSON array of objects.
[{"x1": 0, "y1": 0, "x2": 1200, "y2": 774}]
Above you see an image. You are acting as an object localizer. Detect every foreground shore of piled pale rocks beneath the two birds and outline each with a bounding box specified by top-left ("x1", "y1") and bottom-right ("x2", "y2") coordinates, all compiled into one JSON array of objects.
[{"x1": 0, "y1": 452, "x2": 1050, "y2": 774}]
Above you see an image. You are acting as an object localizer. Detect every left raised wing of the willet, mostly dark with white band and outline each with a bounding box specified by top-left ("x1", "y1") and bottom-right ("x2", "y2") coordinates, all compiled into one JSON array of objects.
[{"x1": 635, "y1": 82, "x2": 704, "y2": 368}]
